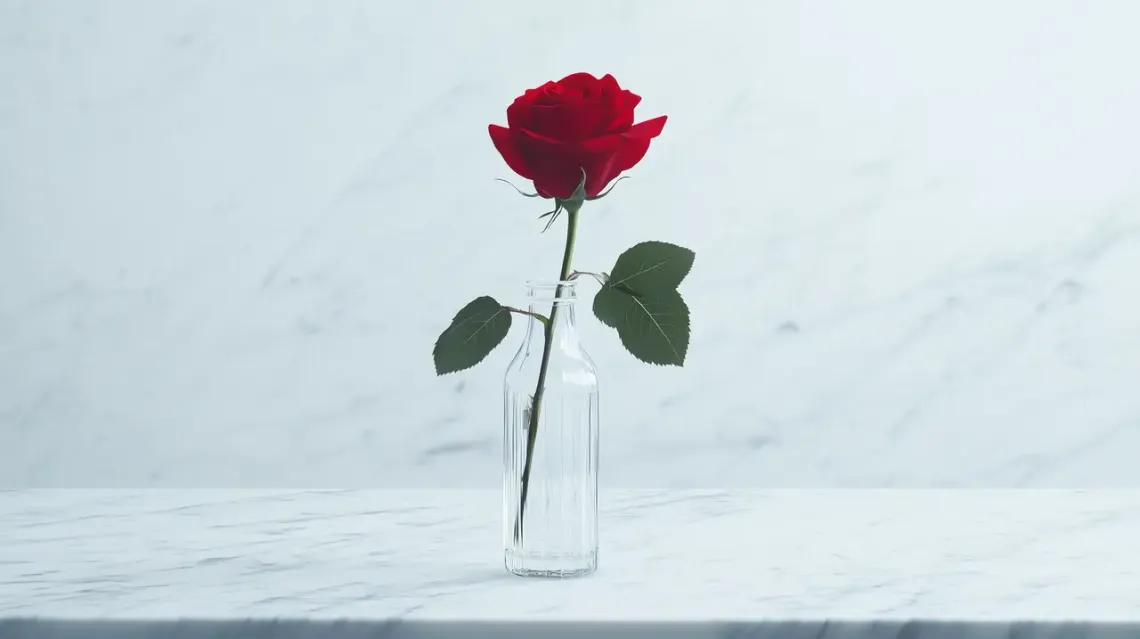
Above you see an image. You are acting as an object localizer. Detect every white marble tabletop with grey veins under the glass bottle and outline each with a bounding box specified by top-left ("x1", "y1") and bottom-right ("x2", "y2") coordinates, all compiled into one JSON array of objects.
[{"x1": 0, "y1": 490, "x2": 1140, "y2": 639}]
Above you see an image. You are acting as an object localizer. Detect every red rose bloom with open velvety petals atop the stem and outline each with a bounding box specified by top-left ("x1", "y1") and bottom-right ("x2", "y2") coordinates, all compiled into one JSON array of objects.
[{"x1": 489, "y1": 73, "x2": 666, "y2": 199}]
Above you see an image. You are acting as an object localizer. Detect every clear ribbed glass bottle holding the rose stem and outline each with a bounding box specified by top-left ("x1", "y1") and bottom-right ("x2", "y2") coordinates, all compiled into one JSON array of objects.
[{"x1": 503, "y1": 276, "x2": 599, "y2": 577}]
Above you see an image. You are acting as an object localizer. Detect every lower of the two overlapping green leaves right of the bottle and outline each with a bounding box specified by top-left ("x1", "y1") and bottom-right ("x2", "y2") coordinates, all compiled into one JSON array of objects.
[{"x1": 594, "y1": 286, "x2": 689, "y2": 366}]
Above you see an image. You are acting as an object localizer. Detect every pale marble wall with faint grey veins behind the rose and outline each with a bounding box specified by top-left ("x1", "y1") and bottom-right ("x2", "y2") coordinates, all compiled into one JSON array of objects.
[{"x1": 0, "y1": 0, "x2": 1140, "y2": 488}]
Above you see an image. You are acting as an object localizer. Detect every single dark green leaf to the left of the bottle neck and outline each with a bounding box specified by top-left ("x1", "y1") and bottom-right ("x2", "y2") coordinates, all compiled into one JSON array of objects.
[{"x1": 432, "y1": 295, "x2": 511, "y2": 375}]
